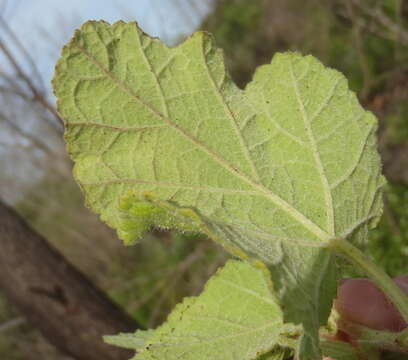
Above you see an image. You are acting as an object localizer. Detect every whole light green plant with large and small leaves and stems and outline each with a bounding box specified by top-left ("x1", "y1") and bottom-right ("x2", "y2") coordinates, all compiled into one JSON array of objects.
[{"x1": 54, "y1": 22, "x2": 408, "y2": 360}]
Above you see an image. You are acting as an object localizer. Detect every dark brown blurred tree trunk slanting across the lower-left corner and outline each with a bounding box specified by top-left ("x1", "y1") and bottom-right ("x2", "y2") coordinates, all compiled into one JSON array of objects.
[{"x1": 0, "y1": 201, "x2": 137, "y2": 360}]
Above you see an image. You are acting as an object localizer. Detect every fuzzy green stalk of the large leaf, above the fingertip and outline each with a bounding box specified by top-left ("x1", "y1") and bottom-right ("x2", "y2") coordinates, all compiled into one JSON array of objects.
[{"x1": 329, "y1": 239, "x2": 408, "y2": 323}]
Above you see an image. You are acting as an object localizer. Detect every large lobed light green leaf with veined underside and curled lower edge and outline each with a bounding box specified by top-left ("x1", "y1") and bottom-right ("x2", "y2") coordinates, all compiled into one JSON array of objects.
[{"x1": 54, "y1": 22, "x2": 383, "y2": 360}]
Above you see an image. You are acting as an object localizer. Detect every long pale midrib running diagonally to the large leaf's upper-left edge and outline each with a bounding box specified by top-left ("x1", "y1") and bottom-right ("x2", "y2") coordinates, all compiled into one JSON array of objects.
[{"x1": 73, "y1": 38, "x2": 333, "y2": 242}]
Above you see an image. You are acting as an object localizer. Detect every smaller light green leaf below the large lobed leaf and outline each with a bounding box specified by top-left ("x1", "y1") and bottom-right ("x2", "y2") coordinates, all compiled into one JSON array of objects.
[{"x1": 102, "y1": 260, "x2": 293, "y2": 360}]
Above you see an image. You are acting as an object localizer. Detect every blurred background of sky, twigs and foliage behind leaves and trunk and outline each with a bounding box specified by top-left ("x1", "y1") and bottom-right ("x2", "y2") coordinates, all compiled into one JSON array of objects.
[{"x1": 0, "y1": 0, "x2": 408, "y2": 360}]
